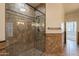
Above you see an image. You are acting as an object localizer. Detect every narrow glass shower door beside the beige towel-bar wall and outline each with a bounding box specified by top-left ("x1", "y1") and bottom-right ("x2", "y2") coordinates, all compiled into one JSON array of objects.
[{"x1": 35, "y1": 16, "x2": 45, "y2": 51}]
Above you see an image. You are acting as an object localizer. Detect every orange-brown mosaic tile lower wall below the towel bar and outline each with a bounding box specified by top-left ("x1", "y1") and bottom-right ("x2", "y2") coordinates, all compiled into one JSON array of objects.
[{"x1": 45, "y1": 33, "x2": 63, "y2": 56}]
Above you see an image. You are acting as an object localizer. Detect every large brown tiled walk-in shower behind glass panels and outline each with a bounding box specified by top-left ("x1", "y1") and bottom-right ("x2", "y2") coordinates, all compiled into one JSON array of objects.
[{"x1": 5, "y1": 3, "x2": 45, "y2": 56}]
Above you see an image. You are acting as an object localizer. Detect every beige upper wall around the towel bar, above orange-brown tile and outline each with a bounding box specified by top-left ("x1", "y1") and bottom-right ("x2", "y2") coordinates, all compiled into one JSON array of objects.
[{"x1": 46, "y1": 3, "x2": 64, "y2": 33}]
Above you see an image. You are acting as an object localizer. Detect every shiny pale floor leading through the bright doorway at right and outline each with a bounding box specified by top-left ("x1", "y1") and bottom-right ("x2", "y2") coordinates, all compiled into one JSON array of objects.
[{"x1": 65, "y1": 32, "x2": 79, "y2": 56}]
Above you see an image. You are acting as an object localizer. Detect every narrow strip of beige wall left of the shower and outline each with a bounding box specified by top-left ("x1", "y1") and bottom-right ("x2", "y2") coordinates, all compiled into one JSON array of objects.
[{"x1": 0, "y1": 3, "x2": 5, "y2": 41}]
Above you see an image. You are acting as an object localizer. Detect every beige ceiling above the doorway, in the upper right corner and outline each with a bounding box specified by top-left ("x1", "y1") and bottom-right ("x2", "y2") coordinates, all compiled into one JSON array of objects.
[{"x1": 63, "y1": 3, "x2": 79, "y2": 13}]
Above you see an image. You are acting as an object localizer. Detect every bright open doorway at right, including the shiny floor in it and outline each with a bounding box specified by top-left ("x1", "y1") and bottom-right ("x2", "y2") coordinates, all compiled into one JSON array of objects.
[{"x1": 66, "y1": 21, "x2": 77, "y2": 56}]
